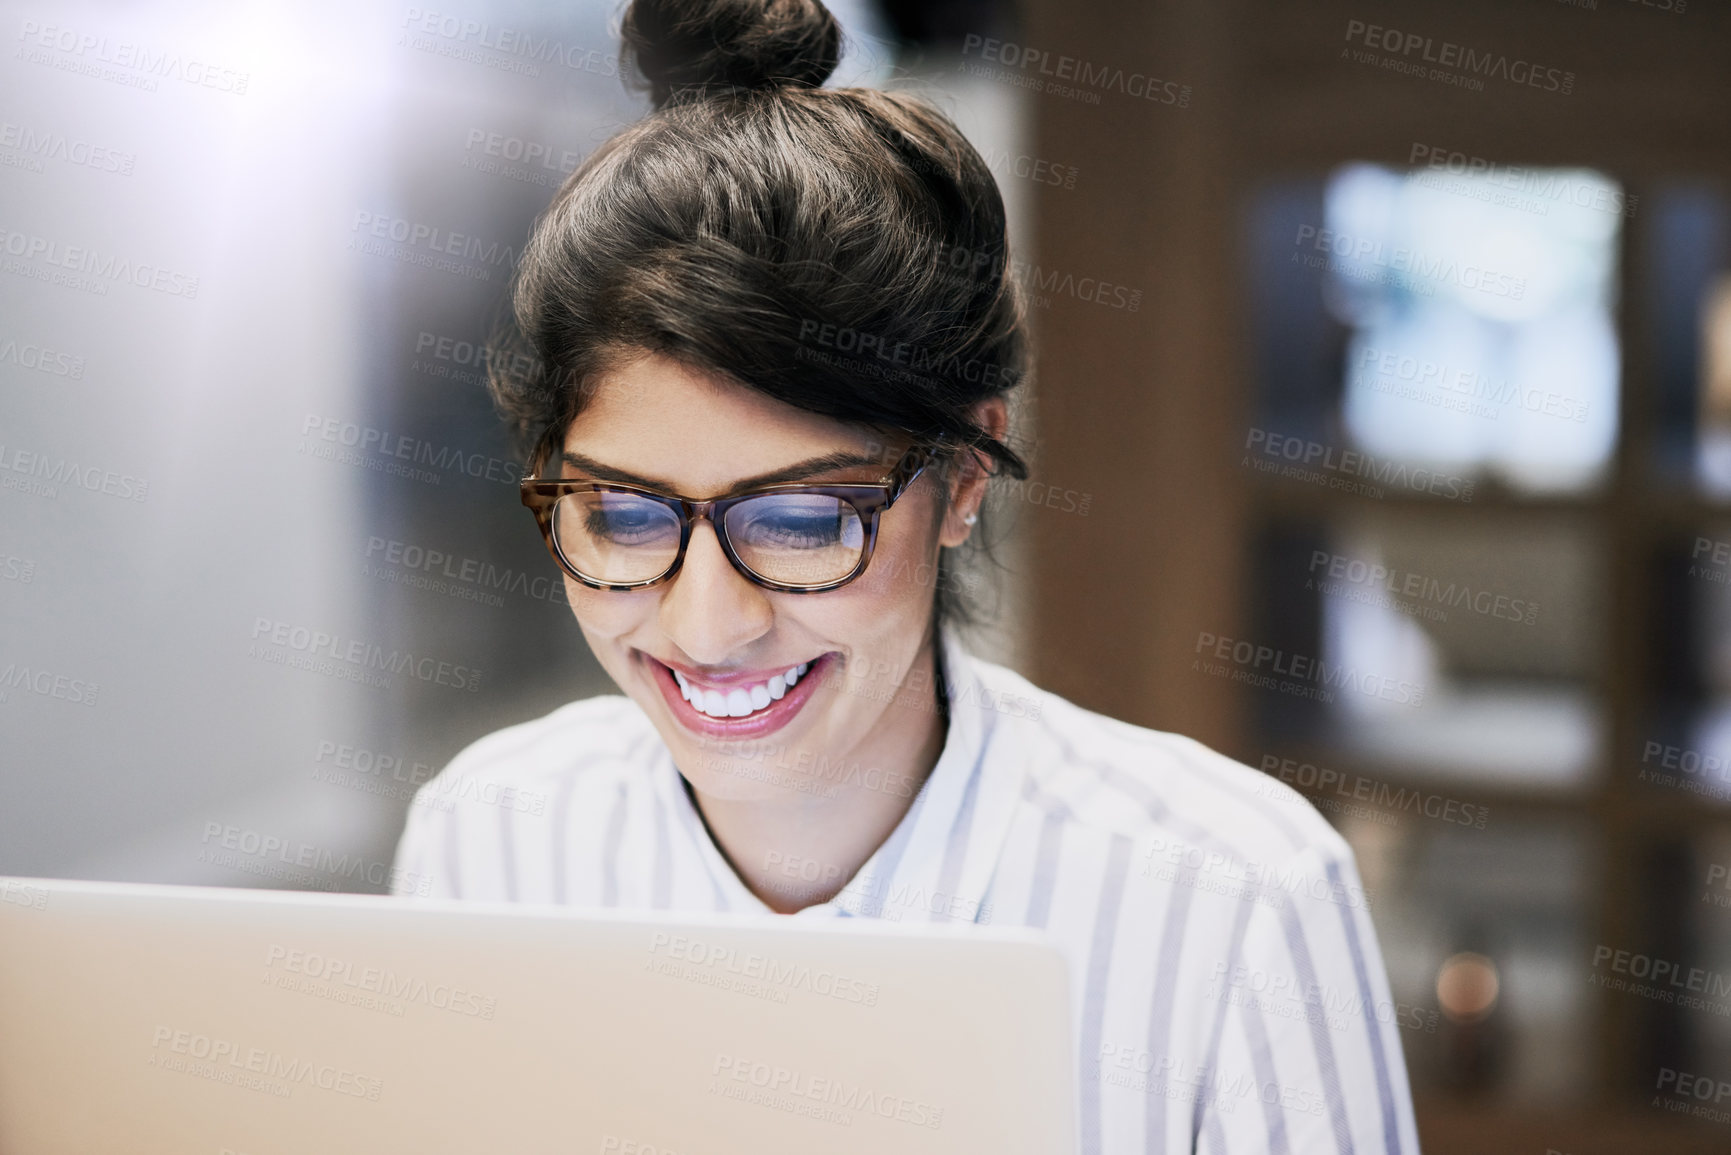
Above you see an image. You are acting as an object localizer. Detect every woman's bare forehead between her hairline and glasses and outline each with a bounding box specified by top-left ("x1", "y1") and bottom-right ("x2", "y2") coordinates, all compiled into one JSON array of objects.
[{"x1": 564, "y1": 353, "x2": 879, "y2": 494}]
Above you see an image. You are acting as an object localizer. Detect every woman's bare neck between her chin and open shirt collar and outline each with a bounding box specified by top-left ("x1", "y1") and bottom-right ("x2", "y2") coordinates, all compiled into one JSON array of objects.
[{"x1": 687, "y1": 641, "x2": 954, "y2": 914}]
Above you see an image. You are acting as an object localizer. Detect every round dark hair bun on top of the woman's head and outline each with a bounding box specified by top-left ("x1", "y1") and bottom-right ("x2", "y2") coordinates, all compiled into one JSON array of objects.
[{"x1": 620, "y1": 0, "x2": 841, "y2": 107}]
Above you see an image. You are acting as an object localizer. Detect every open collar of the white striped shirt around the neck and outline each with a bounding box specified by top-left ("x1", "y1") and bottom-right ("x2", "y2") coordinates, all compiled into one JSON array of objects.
[{"x1": 656, "y1": 629, "x2": 1021, "y2": 923}]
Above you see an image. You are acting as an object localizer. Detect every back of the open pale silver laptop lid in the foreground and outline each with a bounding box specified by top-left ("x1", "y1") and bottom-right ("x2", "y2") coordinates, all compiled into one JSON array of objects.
[{"x1": 0, "y1": 876, "x2": 1077, "y2": 1155}]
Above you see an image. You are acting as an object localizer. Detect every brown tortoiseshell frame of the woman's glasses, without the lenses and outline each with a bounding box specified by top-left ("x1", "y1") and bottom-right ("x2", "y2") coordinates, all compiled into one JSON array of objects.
[{"x1": 518, "y1": 445, "x2": 936, "y2": 594}]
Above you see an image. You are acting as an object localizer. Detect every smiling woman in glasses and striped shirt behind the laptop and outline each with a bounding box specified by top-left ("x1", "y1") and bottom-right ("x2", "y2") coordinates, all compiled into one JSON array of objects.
[{"x1": 398, "y1": 0, "x2": 1418, "y2": 1152}]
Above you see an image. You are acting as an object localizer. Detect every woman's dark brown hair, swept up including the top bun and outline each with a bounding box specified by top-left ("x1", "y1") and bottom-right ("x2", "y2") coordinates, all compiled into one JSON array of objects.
[{"x1": 490, "y1": 0, "x2": 1028, "y2": 633}]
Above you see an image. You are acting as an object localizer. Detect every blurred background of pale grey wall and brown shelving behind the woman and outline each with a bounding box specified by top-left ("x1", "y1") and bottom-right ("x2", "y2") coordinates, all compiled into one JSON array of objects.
[{"x1": 0, "y1": 0, "x2": 1731, "y2": 1155}]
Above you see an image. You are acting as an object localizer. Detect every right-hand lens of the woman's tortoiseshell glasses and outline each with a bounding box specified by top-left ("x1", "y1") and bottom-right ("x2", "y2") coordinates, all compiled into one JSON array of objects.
[{"x1": 727, "y1": 494, "x2": 866, "y2": 585}]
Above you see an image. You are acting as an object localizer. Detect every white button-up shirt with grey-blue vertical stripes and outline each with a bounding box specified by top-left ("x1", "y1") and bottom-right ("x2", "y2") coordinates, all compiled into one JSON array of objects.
[{"x1": 396, "y1": 632, "x2": 1418, "y2": 1155}]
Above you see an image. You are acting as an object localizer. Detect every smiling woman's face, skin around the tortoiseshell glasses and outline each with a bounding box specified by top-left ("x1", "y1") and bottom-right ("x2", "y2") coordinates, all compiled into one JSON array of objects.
[{"x1": 560, "y1": 355, "x2": 975, "y2": 800}]
